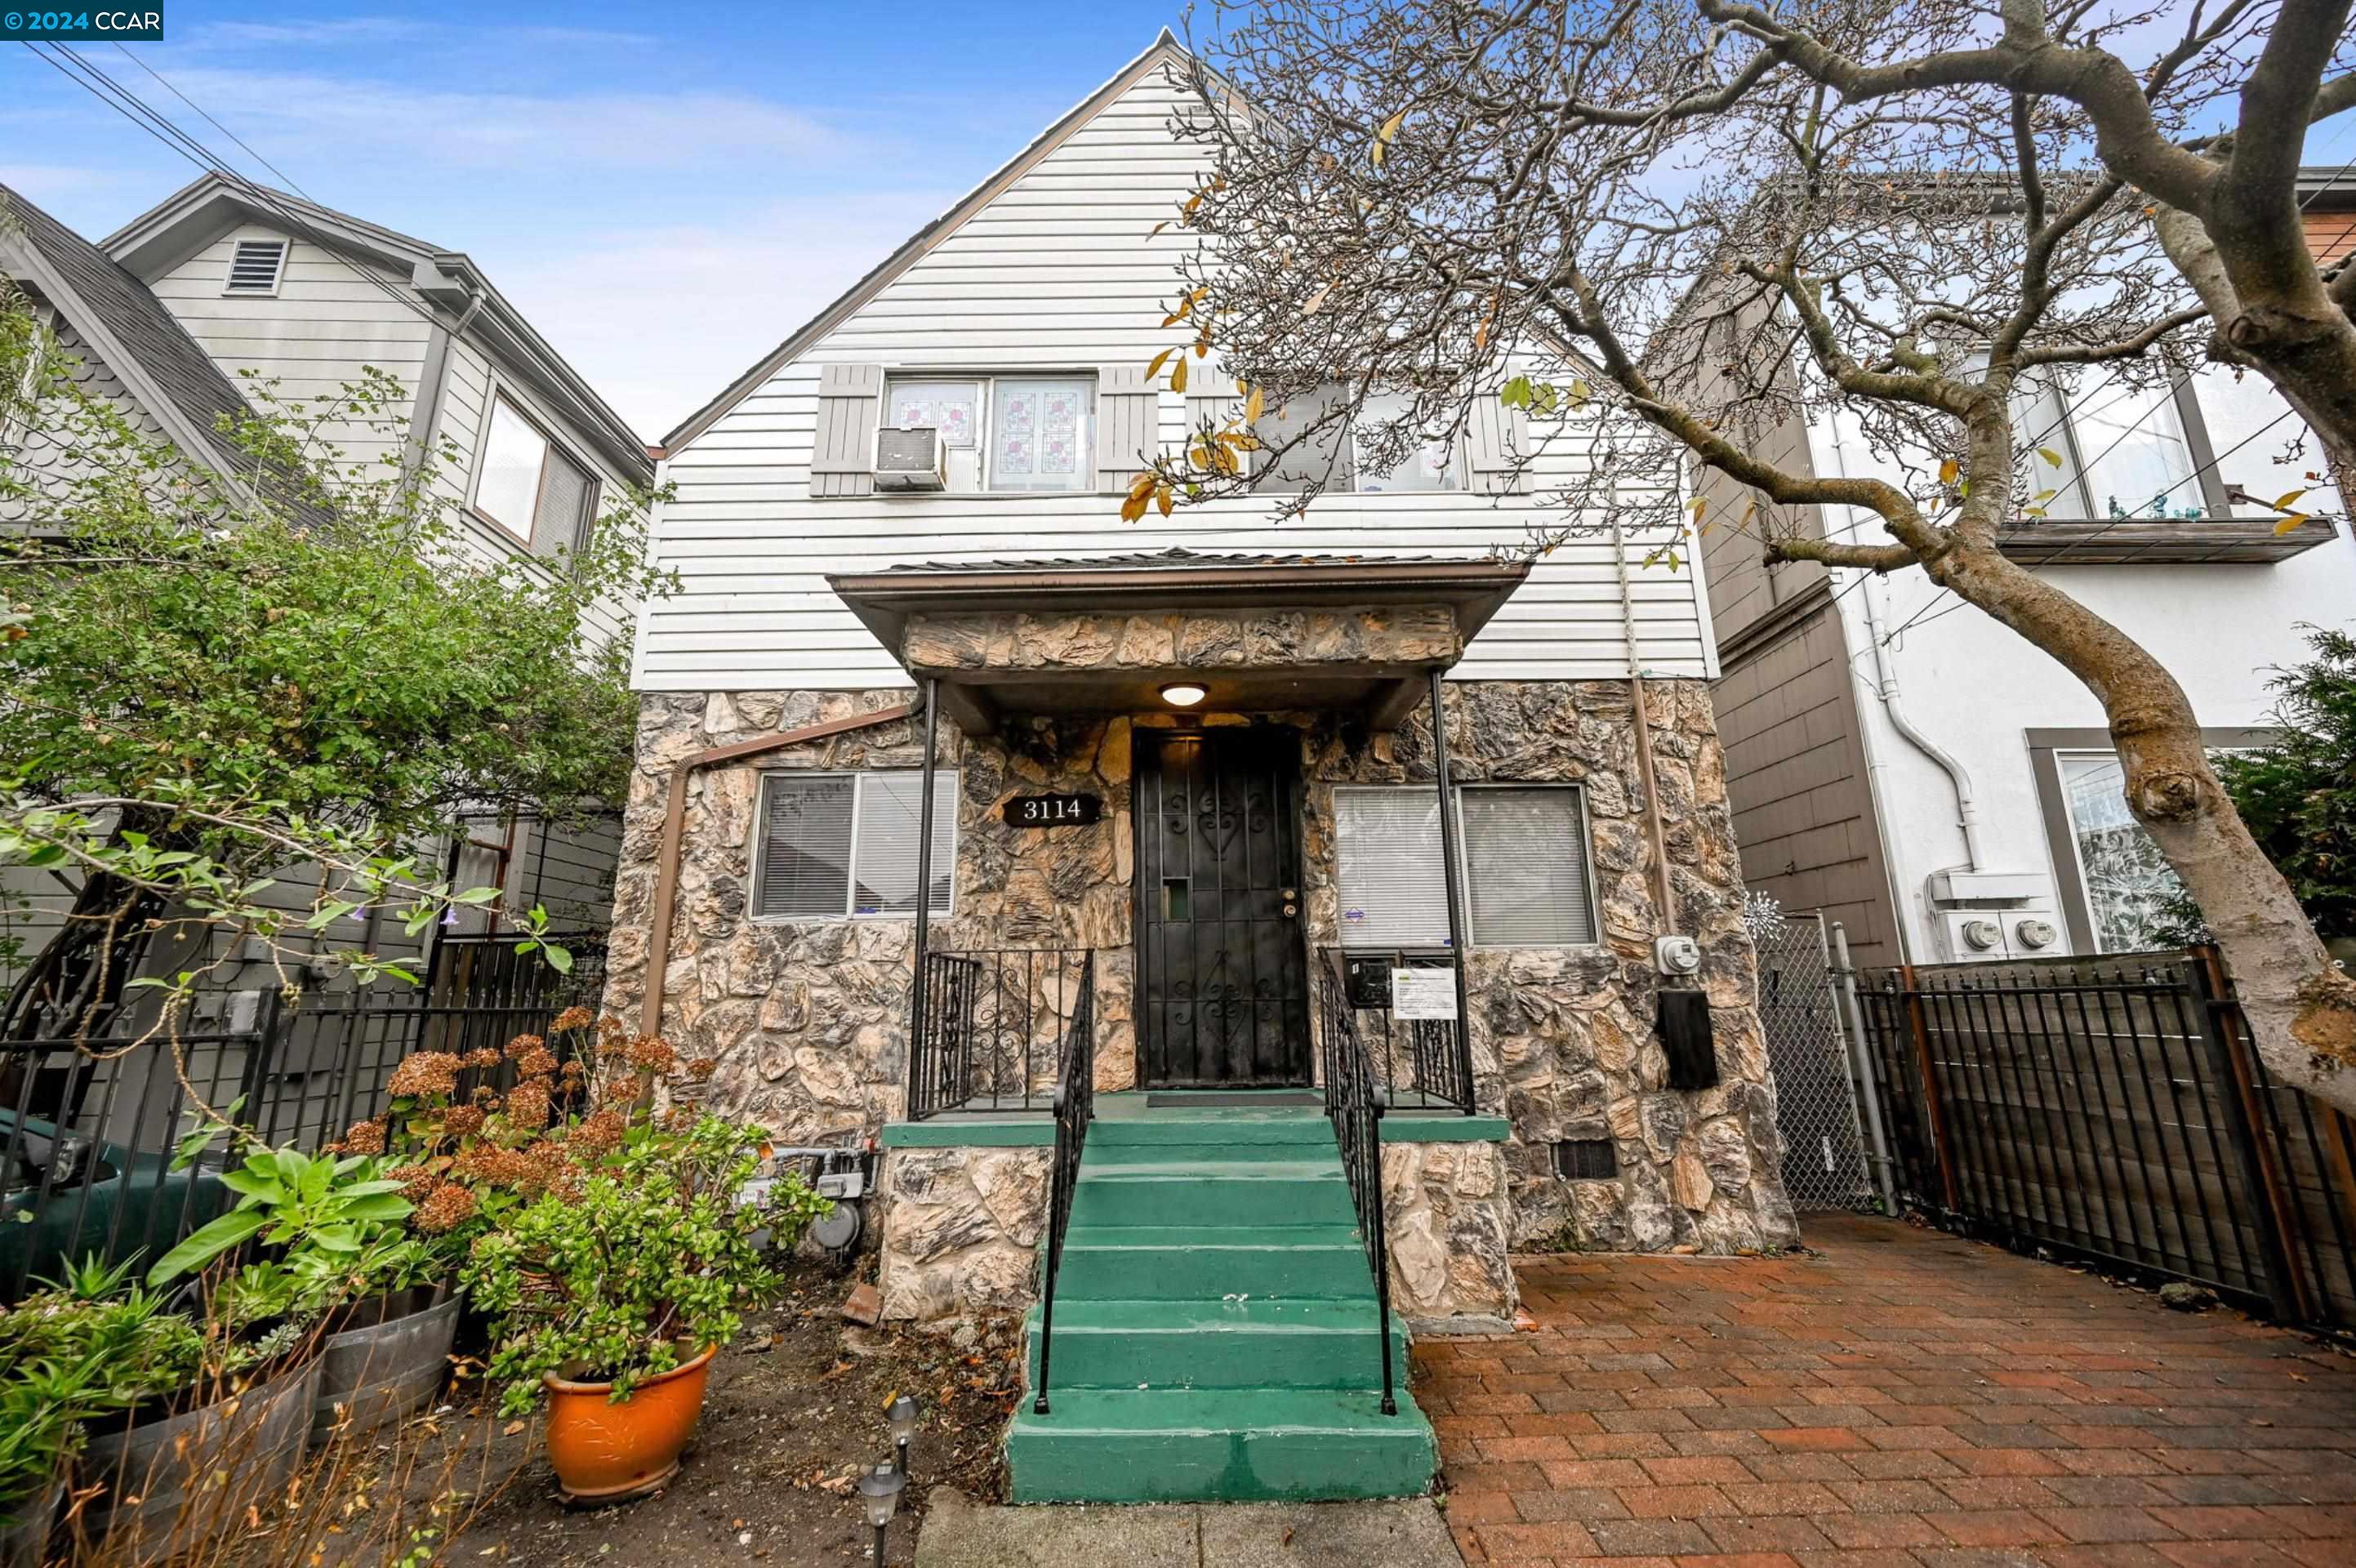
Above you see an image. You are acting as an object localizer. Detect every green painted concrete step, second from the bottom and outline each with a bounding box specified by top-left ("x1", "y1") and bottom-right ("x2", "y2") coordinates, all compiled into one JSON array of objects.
[{"x1": 1025, "y1": 1290, "x2": 1406, "y2": 1389}]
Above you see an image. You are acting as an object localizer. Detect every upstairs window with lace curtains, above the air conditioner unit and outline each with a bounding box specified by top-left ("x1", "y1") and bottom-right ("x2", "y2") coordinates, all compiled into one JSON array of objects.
[{"x1": 884, "y1": 376, "x2": 1096, "y2": 492}]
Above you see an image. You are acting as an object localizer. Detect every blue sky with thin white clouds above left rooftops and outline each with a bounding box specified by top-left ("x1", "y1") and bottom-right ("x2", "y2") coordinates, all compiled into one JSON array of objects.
[{"x1": 0, "y1": 0, "x2": 1180, "y2": 440}]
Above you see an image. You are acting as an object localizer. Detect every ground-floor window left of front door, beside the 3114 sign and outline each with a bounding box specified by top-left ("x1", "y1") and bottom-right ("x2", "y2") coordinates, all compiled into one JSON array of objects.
[{"x1": 751, "y1": 770, "x2": 956, "y2": 920}]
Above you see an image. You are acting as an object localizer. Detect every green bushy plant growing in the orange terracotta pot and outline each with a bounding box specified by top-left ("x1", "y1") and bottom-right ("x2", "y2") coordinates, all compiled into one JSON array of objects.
[{"x1": 464, "y1": 1116, "x2": 799, "y2": 1415}]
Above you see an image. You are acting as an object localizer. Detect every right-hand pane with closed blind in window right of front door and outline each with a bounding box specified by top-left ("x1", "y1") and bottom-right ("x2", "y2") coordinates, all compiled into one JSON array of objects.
[{"x1": 1456, "y1": 786, "x2": 1595, "y2": 947}]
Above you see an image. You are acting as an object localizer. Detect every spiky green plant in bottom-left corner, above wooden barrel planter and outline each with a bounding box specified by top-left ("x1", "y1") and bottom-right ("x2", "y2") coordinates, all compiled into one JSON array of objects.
[{"x1": 0, "y1": 1259, "x2": 205, "y2": 1521}]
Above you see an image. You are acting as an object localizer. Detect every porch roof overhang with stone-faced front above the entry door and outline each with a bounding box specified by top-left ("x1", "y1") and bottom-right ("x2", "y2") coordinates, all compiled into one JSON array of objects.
[{"x1": 827, "y1": 549, "x2": 1529, "y2": 734}]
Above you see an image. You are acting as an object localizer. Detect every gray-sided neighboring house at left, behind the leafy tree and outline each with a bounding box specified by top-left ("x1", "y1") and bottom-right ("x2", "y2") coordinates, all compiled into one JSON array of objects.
[{"x1": 0, "y1": 174, "x2": 652, "y2": 1012}]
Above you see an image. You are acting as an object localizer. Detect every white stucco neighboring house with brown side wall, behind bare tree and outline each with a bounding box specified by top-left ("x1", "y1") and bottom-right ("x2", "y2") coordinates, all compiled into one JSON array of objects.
[{"x1": 1708, "y1": 339, "x2": 2356, "y2": 963}]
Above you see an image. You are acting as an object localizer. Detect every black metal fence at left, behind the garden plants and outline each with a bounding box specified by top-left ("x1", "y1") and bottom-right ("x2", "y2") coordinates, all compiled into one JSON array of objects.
[{"x1": 0, "y1": 937, "x2": 603, "y2": 1302}]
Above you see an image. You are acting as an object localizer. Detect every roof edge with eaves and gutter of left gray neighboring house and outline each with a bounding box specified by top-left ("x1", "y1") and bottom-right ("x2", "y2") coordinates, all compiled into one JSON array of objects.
[{"x1": 99, "y1": 170, "x2": 655, "y2": 483}]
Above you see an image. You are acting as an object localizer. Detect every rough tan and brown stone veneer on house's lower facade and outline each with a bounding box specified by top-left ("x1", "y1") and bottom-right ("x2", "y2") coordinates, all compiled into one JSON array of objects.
[{"x1": 608, "y1": 668, "x2": 1797, "y2": 1318}]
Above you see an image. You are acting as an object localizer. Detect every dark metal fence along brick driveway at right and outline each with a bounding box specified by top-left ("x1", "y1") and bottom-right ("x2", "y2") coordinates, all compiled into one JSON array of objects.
[{"x1": 1856, "y1": 949, "x2": 2356, "y2": 1328}]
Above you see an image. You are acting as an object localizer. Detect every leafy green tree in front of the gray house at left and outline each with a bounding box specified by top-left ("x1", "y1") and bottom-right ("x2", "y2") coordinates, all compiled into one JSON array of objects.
[{"x1": 0, "y1": 285, "x2": 671, "y2": 1007}]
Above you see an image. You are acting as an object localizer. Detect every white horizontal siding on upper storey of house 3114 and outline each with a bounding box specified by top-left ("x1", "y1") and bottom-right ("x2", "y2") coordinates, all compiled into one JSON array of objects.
[{"x1": 636, "y1": 60, "x2": 1712, "y2": 690}]
